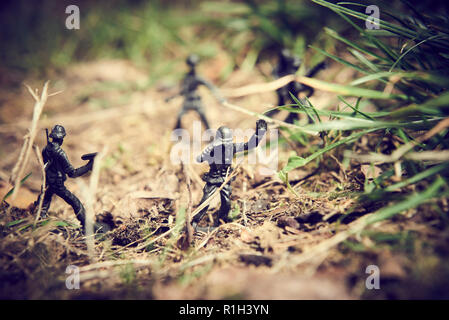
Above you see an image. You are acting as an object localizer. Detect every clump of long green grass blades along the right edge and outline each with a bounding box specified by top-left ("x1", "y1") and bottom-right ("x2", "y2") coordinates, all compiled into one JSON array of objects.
[{"x1": 280, "y1": 0, "x2": 449, "y2": 225}]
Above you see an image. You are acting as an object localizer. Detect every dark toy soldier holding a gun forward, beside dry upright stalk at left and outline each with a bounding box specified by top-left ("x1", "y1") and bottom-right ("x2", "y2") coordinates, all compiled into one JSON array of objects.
[{"x1": 34, "y1": 125, "x2": 98, "y2": 232}]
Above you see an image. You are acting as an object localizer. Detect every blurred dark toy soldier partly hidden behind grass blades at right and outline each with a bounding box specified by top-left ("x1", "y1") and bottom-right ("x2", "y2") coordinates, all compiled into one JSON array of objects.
[{"x1": 266, "y1": 49, "x2": 326, "y2": 123}]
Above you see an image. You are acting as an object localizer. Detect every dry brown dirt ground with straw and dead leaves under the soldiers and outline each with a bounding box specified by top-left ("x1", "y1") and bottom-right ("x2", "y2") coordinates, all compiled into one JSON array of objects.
[{"x1": 0, "y1": 61, "x2": 449, "y2": 299}]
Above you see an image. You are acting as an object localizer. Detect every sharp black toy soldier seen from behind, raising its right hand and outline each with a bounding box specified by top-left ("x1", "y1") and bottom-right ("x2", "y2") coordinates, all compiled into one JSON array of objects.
[{"x1": 193, "y1": 120, "x2": 267, "y2": 230}]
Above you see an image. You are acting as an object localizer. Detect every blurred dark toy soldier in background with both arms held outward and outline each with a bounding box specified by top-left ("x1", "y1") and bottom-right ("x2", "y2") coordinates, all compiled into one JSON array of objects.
[{"x1": 165, "y1": 54, "x2": 225, "y2": 129}]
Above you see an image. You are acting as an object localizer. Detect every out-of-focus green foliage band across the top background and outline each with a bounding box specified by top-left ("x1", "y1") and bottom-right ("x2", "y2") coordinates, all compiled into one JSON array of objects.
[{"x1": 0, "y1": 0, "x2": 335, "y2": 79}]
